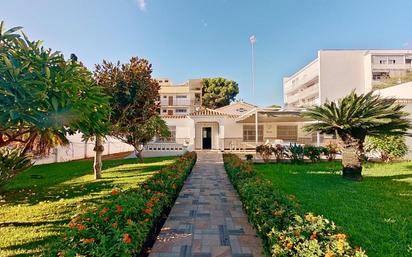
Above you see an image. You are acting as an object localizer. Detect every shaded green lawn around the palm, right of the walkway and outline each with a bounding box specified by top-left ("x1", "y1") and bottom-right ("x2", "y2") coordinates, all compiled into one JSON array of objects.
[{"x1": 255, "y1": 162, "x2": 412, "y2": 257}]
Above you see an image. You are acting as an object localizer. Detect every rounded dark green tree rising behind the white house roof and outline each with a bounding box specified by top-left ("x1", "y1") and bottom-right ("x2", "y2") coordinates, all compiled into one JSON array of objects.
[{"x1": 202, "y1": 78, "x2": 239, "y2": 109}]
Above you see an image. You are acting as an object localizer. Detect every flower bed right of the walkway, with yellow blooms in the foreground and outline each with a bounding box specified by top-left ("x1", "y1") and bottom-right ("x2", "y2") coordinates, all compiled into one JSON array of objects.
[{"x1": 223, "y1": 154, "x2": 367, "y2": 257}]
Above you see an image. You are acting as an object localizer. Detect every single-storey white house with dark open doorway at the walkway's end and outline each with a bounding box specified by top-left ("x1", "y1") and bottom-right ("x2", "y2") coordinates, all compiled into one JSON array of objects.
[{"x1": 146, "y1": 99, "x2": 319, "y2": 154}]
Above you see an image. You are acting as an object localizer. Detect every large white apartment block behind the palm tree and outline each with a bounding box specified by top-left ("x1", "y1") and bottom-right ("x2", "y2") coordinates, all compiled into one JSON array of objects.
[{"x1": 283, "y1": 50, "x2": 412, "y2": 108}]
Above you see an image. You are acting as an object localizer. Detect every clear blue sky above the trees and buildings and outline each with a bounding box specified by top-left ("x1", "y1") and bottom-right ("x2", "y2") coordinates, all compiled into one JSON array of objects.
[{"x1": 0, "y1": 0, "x2": 412, "y2": 106}]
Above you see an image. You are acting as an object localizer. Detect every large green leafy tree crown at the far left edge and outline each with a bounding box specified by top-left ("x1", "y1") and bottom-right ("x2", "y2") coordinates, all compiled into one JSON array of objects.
[{"x1": 0, "y1": 22, "x2": 108, "y2": 178}]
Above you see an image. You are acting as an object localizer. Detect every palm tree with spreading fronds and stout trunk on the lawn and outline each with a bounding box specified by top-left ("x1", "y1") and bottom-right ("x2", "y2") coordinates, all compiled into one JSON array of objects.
[{"x1": 303, "y1": 91, "x2": 410, "y2": 180}]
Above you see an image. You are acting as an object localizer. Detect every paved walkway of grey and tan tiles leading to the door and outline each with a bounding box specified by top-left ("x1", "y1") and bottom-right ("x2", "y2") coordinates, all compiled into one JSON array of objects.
[{"x1": 150, "y1": 151, "x2": 263, "y2": 257}]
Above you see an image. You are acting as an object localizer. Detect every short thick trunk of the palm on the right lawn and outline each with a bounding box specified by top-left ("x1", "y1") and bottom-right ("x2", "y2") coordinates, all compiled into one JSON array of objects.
[{"x1": 342, "y1": 142, "x2": 362, "y2": 181}]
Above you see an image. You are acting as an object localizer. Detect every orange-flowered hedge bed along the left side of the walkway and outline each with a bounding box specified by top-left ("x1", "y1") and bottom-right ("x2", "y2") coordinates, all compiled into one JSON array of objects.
[{"x1": 46, "y1": 152, "x2": 196, "y2": 256}]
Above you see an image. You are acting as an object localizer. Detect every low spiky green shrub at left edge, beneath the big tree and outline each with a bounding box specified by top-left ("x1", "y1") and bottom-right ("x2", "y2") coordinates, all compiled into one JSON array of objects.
[{"x1": 0, "y1": 147, "x2": 33, "y2": 186}]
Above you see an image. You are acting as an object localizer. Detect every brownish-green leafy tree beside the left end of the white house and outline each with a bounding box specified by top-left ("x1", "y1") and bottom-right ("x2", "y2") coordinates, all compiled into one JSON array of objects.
[{"x1": 94, "y1": 57, "x2": 170, "y2": 161}]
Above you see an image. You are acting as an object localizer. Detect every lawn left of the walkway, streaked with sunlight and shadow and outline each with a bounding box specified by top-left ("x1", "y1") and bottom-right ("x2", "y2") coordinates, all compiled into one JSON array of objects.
[{"x1": 0, "y1": 157, "x2": 175, "y2": 257}]
